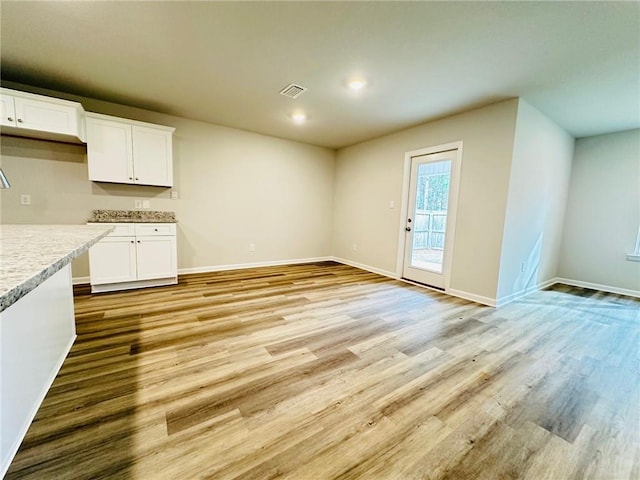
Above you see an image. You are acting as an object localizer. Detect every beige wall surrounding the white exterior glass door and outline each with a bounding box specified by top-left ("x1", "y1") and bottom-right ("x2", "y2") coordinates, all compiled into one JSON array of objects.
[{"x1": 333, "y1": 99, "x2": 518, "y2": 299}]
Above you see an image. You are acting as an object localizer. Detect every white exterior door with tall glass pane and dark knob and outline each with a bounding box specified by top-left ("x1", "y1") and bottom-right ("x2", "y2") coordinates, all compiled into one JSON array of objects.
[{"x1": 402, "y1": 149, "x2": 460, "y2": 290}]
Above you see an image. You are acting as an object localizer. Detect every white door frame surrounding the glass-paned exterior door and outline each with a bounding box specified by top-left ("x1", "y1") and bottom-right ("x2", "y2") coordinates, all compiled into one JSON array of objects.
[{"x1": 396, "y1": 140, "x2": 462, "y2": 292}]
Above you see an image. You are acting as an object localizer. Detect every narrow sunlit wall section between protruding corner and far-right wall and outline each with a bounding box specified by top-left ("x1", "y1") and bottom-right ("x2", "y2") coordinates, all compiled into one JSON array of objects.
[{"x1": 497, "y1": 99, "x2": 574, "y2": 303}]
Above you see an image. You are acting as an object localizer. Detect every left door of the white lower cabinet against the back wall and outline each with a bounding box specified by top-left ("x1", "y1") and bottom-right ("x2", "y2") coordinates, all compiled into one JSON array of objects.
[{"x1": 89, "y1": 237, "x2": 137, "y2": 285}]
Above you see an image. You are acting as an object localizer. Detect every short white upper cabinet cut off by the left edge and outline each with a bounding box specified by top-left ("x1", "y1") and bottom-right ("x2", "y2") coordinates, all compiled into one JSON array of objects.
[{"x1": 0, "y1": 88, "x2": 85, "y2": 143}]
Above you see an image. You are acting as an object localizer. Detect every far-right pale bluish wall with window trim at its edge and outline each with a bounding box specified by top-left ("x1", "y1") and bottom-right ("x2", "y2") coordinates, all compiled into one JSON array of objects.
[{"x1": 559, "y1": 130, "x2": 640, "y2": 295}]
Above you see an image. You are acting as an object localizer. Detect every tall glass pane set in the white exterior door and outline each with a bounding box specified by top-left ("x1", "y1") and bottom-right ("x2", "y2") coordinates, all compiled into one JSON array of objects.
[{"x1": 411, "y1": 160, "x2": 451, "y2": 273}]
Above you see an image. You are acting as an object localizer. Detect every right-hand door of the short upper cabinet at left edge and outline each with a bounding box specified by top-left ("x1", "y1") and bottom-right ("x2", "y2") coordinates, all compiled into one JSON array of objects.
[{"x1": 14, "y1": 97, "x2": 78, "y2": 135}]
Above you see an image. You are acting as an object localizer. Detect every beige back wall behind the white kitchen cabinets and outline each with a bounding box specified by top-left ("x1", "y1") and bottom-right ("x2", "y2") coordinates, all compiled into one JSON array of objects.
[{"x1": 0, "y1": 86, "x2": 335, "y2": 277}]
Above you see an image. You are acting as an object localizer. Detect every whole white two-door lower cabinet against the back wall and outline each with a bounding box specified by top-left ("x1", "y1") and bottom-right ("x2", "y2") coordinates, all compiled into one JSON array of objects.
[{"x1": 89, "y1": 223, "x2": 178, "y2": 293}]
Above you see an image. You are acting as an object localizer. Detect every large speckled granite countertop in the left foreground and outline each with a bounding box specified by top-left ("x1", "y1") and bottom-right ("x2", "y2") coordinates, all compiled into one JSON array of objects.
[{"x1": 0, "y1": 225, "x2": 113, "y2": 312}]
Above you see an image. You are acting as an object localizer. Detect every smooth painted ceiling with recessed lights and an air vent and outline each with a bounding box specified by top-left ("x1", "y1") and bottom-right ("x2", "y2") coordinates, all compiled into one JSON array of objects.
[{"x1": 0, "y1": 0, "x2": 640, "y2": 148}]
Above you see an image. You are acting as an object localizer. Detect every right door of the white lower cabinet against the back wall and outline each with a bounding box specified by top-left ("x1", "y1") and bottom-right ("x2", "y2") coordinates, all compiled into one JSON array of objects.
[{"x1": 136, "y1": 236, "x2": 178, "y2": 280}]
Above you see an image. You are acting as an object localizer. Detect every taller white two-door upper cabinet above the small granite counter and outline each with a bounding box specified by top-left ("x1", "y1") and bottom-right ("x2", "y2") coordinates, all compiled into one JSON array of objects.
[{"x1": 86, "y1": 113, "x2": 175, "y2": 187}]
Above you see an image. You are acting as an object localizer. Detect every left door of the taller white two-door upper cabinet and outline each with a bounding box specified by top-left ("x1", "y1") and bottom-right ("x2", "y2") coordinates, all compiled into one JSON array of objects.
[{"x1": 86, "y1": 117, "x2": 134, "y2": 183}]
